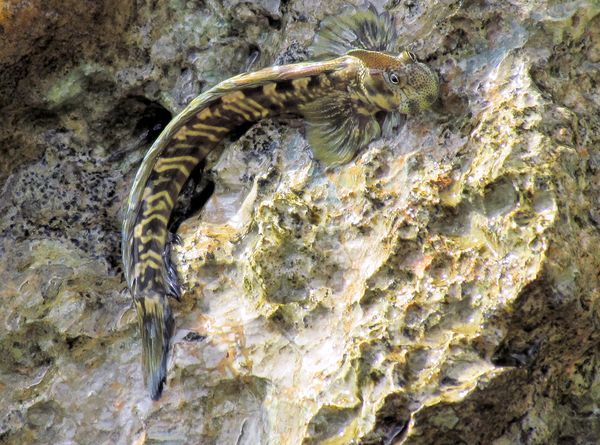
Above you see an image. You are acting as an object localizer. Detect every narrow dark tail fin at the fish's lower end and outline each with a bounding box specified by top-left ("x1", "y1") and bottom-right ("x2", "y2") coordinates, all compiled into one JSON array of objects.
[{"x1": 135, "y1": 293, "x2": 173, "y2": 400}]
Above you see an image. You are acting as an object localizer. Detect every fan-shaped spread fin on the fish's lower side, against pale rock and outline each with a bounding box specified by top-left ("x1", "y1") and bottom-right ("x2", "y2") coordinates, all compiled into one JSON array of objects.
[{"x1": 302, "y1": 95, "x2": 381, "y2": 166}]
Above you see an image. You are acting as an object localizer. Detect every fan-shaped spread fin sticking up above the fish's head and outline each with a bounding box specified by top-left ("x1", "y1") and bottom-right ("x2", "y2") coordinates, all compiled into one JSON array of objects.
[{"x1": 310, "y1": 5, "x2": 398, "y2": 59}]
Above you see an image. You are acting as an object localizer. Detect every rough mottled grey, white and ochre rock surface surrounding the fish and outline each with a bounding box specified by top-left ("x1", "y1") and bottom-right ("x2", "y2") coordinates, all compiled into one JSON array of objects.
[{"x1": 0, "y1": 0, "x2": 600, "y2": 445}]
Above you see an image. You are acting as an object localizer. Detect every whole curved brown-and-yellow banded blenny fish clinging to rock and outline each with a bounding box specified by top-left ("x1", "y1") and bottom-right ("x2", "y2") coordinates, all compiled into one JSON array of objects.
[{"x1": 122, "y1": 6, "x2": 439, "y2": 400}]
